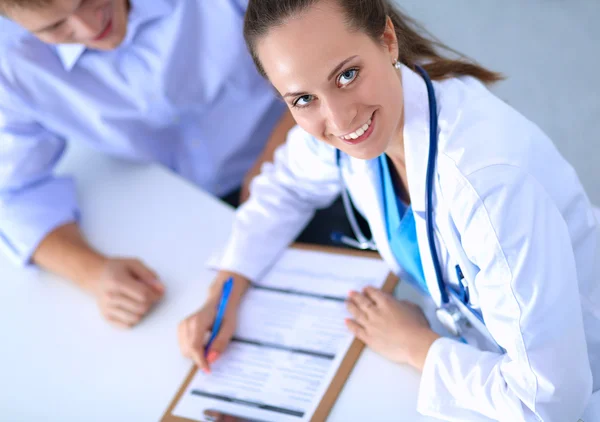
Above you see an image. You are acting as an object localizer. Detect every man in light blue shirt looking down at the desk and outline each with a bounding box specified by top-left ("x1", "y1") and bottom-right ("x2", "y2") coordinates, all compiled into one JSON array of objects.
[{"x1": 0, "y1": 0, "x2": 293, "y2": 327}]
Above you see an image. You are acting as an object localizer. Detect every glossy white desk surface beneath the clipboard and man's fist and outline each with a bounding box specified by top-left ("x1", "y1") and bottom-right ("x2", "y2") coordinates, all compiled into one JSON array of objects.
[{"x1": 0, "y1": 149, "x2": 433, "y2": 422}]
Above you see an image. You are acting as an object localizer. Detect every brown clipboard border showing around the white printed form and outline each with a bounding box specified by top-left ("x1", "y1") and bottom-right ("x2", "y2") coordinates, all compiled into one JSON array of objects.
[{"x1": 161, "y1": 243, "x2": 399, "y2": 422}]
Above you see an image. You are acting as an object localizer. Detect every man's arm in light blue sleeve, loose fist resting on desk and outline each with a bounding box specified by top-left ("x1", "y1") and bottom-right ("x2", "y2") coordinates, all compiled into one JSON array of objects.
[{"x1": 0, "y1": 80, "x2": 162, "y2": 326}]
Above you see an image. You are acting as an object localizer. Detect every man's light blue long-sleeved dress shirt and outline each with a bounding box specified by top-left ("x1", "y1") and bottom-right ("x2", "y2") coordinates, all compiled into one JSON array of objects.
[{"x1": 0, "y1": 0, "x2": 284, "y2": 263}]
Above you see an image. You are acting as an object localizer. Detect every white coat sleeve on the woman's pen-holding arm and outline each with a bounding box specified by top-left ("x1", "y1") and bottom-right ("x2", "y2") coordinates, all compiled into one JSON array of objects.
[{"x1": 220, "y1": 126, "x2": 341, "y2": 280}]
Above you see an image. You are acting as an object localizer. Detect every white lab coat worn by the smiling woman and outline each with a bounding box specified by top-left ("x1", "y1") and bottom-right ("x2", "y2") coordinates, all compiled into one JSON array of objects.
[{"x1": 221, "y1": 67, "x2": 600, "y2": 422}]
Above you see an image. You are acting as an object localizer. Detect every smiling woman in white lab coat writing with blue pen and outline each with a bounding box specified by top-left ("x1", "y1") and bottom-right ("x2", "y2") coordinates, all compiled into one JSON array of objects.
[{"x1": 179, "y1": 0, "x2": 600, "y2": 422}]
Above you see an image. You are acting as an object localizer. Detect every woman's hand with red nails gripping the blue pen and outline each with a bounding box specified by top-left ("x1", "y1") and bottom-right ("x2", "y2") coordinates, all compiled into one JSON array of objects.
[{"x1": 178, "y1": 271, "x2": 250, "y2": 373}]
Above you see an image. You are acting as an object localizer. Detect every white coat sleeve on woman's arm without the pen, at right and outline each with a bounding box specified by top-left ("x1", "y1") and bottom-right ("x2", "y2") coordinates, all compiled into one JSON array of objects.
[{"x1": 418, "y1": 165, "x2": 592, "y2": 422}]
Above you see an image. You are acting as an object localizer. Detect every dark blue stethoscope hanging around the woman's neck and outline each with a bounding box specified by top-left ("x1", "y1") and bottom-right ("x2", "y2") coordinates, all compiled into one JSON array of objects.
[{"x1": 331, "y1": 66, "x2": 503, "y2": 350}]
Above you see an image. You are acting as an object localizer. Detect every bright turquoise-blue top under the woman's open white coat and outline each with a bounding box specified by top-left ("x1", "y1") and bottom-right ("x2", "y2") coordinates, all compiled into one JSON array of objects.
[{"x1": 379, "y1": 154, "x2": 429, "y2": 295}]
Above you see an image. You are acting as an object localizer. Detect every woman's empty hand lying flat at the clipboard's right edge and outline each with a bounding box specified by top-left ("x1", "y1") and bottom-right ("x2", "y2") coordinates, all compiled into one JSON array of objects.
[{"x1": 346, "y1": 287, "x2": 440, "y2": 370}]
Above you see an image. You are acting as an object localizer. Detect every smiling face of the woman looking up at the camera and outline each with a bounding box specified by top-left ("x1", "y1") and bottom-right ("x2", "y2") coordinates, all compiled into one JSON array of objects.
[{"x1": 257, "y1": 0, "x2": 403, "y2": 159}]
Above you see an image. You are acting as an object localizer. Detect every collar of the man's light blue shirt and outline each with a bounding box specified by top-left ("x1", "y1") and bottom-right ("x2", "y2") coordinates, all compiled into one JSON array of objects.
[{"x1": 55, "y1": 0, "x2": 173, "y2": 71}]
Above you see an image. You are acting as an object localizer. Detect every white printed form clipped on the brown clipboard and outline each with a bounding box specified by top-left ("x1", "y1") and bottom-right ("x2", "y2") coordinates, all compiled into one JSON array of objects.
[{"x1": 173, "y1": 249, "x2": 389, "y2": 422}]
